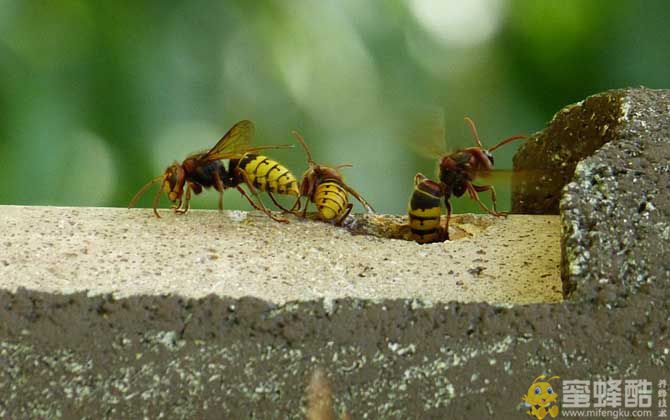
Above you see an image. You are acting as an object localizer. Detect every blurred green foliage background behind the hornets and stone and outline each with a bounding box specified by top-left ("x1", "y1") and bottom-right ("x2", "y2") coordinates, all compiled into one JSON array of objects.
[{"x1": 0, "y1": 0, "x2": 670, "y2": 213}]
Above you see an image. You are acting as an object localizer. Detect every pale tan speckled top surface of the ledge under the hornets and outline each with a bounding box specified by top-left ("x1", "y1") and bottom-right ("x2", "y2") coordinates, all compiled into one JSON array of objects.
[{"x1": 0, "y1": 206, "x2": 562, "y2": 303}]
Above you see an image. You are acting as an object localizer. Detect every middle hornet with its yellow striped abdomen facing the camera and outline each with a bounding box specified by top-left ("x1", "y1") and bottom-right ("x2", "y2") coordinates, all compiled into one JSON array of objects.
[{"x1": 292, "y1": 131, "x2": 374, "y2": 226}]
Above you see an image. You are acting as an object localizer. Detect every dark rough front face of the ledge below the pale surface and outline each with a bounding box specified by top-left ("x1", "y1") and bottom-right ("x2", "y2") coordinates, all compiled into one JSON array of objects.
[{"x1": 0, "y1": 289, "x2": 670, "y2": 419}]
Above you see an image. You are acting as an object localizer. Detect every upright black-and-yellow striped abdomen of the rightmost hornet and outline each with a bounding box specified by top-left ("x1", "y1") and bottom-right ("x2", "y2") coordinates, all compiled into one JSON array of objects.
[{"x1": 409, "y1": 174, "x2": 442, "y2": 244}]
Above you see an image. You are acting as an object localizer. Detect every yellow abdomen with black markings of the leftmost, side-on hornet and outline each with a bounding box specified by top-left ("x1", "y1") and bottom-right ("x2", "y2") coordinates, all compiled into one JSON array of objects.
[{"x1": 238, "y1": 153, "x2": 300, "y2": 196}]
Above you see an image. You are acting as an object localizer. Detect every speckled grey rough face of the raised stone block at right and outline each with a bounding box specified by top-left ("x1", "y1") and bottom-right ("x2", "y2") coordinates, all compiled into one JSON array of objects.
[{"x1": 561, "y1": 89, "x2": 670, "y2": 298}]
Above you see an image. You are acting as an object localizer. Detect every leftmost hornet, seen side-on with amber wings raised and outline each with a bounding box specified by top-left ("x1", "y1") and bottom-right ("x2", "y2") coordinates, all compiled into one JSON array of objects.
[{"x1": 128, "y1": 120, "x2": 300, "y2": 222}]
